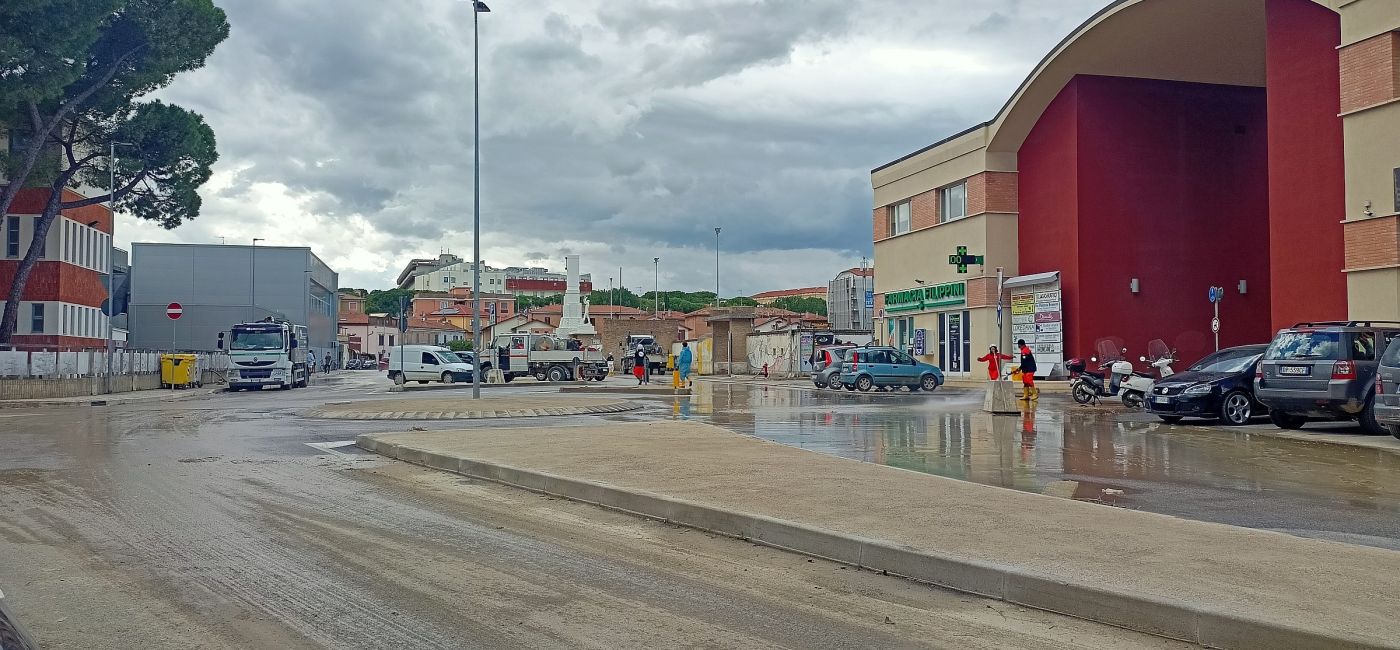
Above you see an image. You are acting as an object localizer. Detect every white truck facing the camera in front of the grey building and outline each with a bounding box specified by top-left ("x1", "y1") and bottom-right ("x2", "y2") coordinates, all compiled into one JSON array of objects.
[{"x1": 218, "y1": 318, "x2": 311, "y2": 391}]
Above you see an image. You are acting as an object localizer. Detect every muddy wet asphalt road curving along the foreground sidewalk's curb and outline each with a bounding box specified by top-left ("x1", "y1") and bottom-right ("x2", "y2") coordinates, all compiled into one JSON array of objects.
[{"x1": 0, "y1": 375, "x2": 1177, "y2": 649}]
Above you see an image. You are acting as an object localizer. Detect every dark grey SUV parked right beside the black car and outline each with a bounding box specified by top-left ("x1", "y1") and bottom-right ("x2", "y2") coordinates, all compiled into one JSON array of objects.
[{"x1": 1254, "y1": 321, "x2": 1400, "y2": 434}]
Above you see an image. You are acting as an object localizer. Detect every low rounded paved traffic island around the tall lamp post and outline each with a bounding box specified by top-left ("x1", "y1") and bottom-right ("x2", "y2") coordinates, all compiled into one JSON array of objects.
[{"x1": 305, "y1": 395, "x2": 641, "y2": 420}]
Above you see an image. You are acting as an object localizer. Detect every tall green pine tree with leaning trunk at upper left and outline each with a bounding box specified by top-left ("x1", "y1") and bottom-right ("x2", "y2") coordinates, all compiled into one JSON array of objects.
[{"x1": 0, "y1": 0, "x2": 228, "y2": 343}]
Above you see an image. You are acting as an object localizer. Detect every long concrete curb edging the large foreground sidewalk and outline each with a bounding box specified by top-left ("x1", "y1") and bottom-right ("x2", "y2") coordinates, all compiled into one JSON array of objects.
[{"x1": 356, "y1": 434, "x2": 1400, "y2": 650}]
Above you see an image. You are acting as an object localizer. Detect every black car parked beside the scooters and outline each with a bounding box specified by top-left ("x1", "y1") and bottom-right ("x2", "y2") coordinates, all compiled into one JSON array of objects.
[{"x1": 1145, "y1": 345, "x2": 1268, "y2": 426}]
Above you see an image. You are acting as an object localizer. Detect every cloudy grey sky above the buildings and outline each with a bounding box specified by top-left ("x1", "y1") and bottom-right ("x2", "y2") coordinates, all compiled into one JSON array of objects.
[{"x1": 118, "y1": 0, "x2": 1107, "y2": 294}]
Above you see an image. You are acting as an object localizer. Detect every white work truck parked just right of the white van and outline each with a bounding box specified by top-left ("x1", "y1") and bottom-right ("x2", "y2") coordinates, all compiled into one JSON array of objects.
[{"x1": 480, "y1": 333, "x2": 608, "y2": 381}]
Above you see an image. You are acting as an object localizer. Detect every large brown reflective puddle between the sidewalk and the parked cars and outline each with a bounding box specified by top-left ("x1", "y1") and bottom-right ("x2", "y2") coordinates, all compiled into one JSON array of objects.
[{"x1": 668, "y1": 382, "x2": 1400, "y2": 548}]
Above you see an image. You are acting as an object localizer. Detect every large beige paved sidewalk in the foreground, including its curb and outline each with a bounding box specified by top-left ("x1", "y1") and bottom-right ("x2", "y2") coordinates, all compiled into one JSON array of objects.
[{"x1": 358, "y1": 422, "x2": 1400, "y2": 649}]
